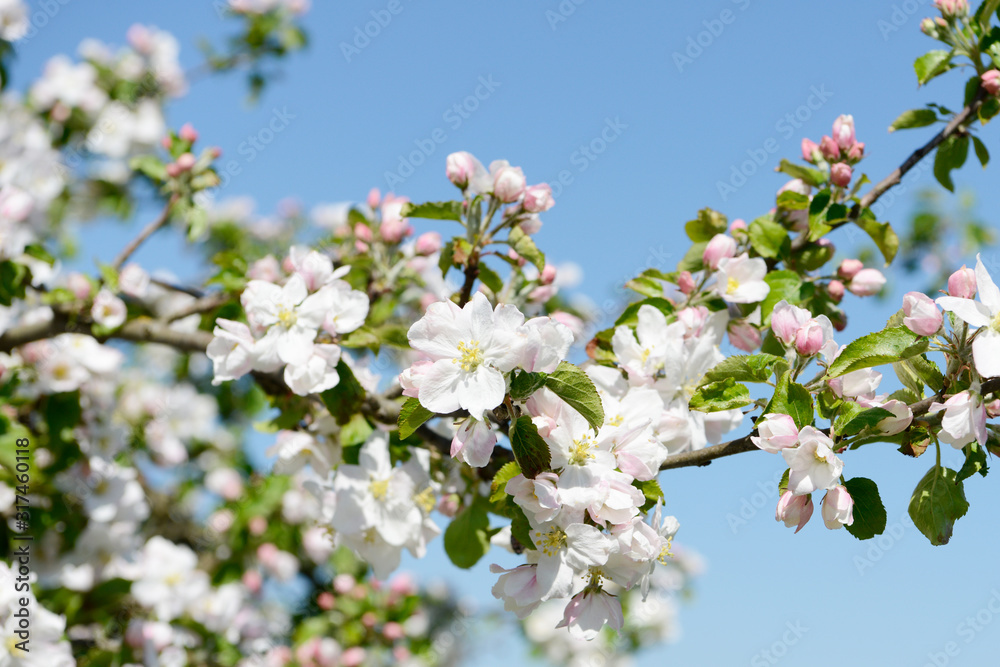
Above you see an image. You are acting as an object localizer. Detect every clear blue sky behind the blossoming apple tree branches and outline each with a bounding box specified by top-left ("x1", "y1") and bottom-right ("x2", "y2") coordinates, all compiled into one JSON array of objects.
[{"x1": 14, "y1": 0, "x2": 1000, "y2": 666}]
